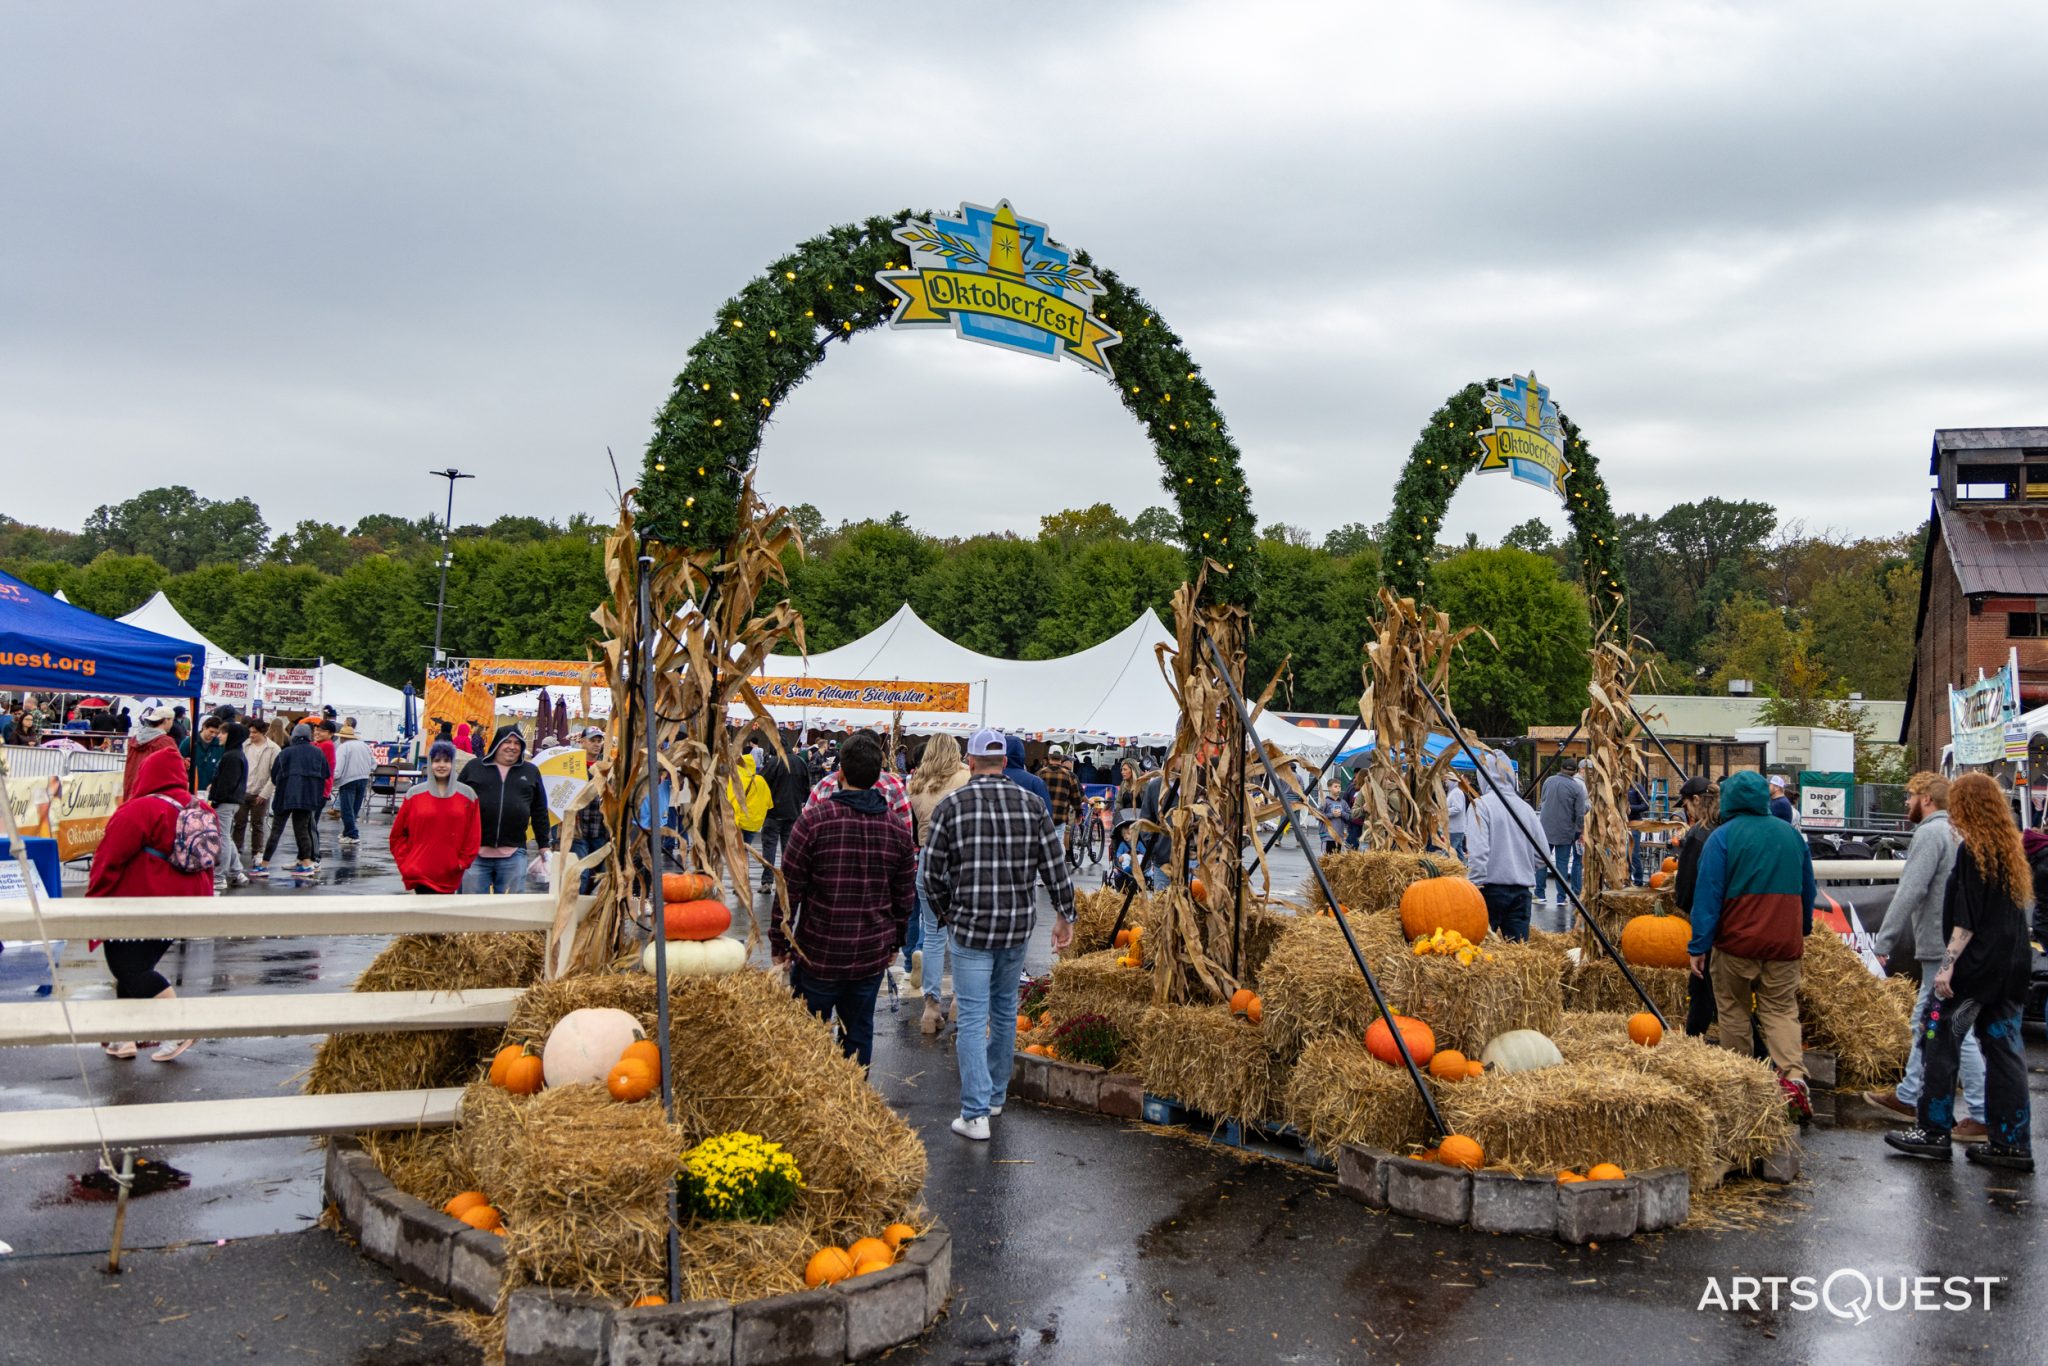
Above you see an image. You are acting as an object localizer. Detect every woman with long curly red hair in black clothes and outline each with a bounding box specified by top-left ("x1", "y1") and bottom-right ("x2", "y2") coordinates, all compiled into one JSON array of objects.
[{"x1": 1884, "y1": 772, "x2": 2034, "y2": 1171}]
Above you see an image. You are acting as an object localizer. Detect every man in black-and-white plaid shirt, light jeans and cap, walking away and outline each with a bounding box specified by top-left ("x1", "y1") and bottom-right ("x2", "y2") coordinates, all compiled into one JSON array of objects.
[{"x1": 924, "y1": 731, "x2": 1073, "y2": 1143}]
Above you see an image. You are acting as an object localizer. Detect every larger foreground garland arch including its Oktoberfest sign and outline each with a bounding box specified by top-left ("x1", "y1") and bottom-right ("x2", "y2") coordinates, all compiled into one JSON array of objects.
[{"x1": 639, "y1": 201, "x2": 1257, "y2": 606}]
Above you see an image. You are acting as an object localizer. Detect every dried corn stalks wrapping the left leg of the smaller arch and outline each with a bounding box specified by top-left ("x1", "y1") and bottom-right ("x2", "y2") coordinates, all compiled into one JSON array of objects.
[{"x1": 1358, "y1": 588, "x2": 1493, "y2": 854}]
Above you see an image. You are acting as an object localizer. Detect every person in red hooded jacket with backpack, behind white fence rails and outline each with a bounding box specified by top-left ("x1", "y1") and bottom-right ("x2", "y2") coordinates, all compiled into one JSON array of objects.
[{"x1": 86, "y1": 741, "x2": 213, "y2": 1063}]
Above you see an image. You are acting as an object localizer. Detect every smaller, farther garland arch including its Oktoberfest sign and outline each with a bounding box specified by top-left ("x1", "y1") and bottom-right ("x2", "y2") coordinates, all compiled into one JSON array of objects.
[{"x1": 1380, "y1": 375, "x2": 1628, "y2": 633}]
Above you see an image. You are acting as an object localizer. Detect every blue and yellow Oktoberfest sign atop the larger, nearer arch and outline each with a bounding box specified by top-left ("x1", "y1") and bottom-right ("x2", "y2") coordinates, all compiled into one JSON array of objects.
[{"x1": 874, "y1": 199, "x2": 1122, "y2": 375}]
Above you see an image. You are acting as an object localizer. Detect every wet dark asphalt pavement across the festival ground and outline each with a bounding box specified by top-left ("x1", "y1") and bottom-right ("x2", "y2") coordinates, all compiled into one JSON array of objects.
[{"x1": 0, "y1": 815, "x2": 2048, "y2": 1366}]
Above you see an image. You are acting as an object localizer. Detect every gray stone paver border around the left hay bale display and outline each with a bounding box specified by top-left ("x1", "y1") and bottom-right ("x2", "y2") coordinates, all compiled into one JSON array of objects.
[{"x1": 326, "y1": 1139, "x2": 952, "y2": 1366}]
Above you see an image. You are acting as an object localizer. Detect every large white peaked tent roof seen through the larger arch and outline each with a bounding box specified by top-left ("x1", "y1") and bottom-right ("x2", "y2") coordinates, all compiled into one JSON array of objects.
[{"x1": 498, "y1": 602, "x2": 1337, "y2": 764}]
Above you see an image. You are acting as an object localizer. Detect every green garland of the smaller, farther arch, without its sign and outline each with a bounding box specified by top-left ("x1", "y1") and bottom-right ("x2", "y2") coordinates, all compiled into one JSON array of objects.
[{"x1": 1380, "y1": 379, "x2": 1628, "y2": 631}]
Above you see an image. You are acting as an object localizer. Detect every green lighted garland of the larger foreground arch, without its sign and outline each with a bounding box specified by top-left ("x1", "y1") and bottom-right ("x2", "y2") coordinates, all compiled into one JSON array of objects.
[{"x1": 639, "y1": 211, "x2": 1257, "y2": 606}]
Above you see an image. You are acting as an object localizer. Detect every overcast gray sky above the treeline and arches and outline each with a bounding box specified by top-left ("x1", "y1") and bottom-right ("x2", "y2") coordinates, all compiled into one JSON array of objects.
[{"x1": 0, "y1": 0, "x2": 2048, "y2": 539}]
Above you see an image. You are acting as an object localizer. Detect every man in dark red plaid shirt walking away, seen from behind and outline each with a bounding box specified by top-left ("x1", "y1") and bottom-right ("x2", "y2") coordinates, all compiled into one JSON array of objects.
[{"x1": 768, "y1": 735, "x2": 917, "y2": 1067}]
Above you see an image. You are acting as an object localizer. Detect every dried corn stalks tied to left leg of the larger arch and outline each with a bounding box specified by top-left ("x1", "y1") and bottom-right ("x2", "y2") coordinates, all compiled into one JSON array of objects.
[{"x1": 547, "y1": 477, "x2": 803, "y2": 977}]
